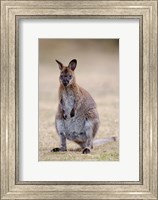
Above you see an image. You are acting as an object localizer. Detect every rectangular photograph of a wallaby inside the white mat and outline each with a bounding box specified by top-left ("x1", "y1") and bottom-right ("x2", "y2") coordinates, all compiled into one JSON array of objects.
[{"x1": 38, "y1": 38, "x2": 119, "y2": 161}]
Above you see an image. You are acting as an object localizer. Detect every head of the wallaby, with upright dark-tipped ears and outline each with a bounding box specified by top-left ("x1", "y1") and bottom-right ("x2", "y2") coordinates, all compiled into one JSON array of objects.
[{"x1": 56, "y1": 59, "x2": 77, "y2": 87}]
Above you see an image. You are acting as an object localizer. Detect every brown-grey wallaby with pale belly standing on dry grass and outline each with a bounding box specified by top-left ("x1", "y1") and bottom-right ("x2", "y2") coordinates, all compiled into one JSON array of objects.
[{"x1": 51, "y1": 59, "x2": 116, "y2": 154}]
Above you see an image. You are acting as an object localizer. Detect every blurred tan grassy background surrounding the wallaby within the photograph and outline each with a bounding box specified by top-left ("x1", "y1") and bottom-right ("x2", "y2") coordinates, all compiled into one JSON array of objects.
[{"x1": 39, "y1": 39, "x2": 119, "y2": 160}]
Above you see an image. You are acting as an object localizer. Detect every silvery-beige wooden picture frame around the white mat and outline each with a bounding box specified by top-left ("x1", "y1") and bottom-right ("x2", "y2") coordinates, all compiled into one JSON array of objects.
[{"x1": 0, "y1": 0, "x2": 157, "y2": 199}]
